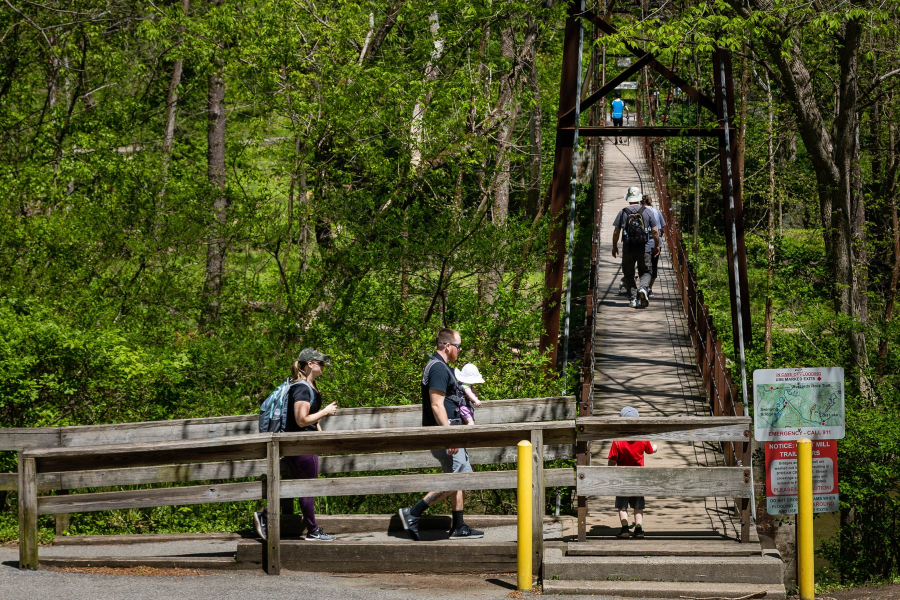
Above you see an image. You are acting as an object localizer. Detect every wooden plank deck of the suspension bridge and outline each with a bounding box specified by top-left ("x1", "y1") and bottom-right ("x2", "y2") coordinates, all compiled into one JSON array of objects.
[{"x1": 587, "y1": 138, "x2": 744, "y2": 542}]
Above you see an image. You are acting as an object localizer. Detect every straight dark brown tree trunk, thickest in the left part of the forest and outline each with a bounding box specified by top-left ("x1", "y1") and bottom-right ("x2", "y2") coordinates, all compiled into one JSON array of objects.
[{"x1": 205, "y1": 0, "x2": 228, "y2": 322}]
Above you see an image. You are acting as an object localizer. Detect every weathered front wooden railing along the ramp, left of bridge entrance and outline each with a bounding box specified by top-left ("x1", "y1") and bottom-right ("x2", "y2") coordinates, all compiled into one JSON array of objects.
[{"x1": 18, "y1": 420, "x2": 575, "y2": 573}]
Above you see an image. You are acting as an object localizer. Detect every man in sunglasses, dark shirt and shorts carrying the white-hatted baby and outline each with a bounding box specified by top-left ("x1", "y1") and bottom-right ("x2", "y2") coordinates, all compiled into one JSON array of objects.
[{"x1": 398, "y1": 329, "x2": 484, "y2": 540}]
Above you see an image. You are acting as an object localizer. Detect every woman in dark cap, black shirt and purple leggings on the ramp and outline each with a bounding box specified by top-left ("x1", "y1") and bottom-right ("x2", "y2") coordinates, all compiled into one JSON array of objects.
[{"x1": 253, "y1": 348, "x2": 337, "y2": 542}]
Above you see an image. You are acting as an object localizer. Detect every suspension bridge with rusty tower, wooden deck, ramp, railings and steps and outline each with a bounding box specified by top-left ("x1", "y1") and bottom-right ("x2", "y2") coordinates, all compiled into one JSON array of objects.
[{"x1": 0, "y1": 1, "x2": 785, "y2": 598}]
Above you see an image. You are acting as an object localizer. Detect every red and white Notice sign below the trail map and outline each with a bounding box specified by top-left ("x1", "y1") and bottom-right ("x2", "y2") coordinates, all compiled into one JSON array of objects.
[{"x1": 766, "y1": 440, "x2": 839, "y2": 515}]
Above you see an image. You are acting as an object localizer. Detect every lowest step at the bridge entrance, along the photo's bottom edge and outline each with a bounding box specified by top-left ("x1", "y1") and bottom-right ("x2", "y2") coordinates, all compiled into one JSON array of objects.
[{"x1": 544, "y1": 579, "x2": 787, "y2": 600}]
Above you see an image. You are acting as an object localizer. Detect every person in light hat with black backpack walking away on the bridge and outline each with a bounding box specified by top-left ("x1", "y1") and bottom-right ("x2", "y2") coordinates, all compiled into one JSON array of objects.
[{"x1": 612, "y1": 186, "x2": 660, "y2": 308}]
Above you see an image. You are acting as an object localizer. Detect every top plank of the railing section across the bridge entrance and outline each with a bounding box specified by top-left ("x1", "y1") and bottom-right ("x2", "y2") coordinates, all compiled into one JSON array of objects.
[{"x1": 576, "y1": 417, "x2": 751, "y2": 442}]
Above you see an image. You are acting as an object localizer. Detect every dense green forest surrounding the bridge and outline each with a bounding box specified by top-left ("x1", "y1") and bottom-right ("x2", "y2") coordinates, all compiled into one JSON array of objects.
[{"x1": 0, "y1": 0, "x2": 900, "y2": 582}]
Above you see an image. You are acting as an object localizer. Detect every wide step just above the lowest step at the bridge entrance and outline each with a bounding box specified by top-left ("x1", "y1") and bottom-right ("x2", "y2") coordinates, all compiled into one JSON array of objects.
[{"x1": 544, "y1": 549, "x2": 783, "y2": 585}]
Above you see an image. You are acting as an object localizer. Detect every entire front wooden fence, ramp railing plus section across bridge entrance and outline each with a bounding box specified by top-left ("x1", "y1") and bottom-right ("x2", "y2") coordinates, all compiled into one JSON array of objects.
[{"x1": 18, "y1": 412, "x2": 751, "y2": 573}]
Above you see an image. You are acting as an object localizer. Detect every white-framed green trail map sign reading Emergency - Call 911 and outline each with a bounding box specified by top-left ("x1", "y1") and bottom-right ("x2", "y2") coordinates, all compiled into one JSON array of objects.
[{"x1": 753, "y1": 367, "x2": 844, "y2": 442}]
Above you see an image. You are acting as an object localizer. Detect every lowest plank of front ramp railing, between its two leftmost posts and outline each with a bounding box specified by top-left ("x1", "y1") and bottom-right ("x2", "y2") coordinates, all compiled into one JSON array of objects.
[{"x1": 37, "y1": 481, "x2": 265, "y2": 515}]
